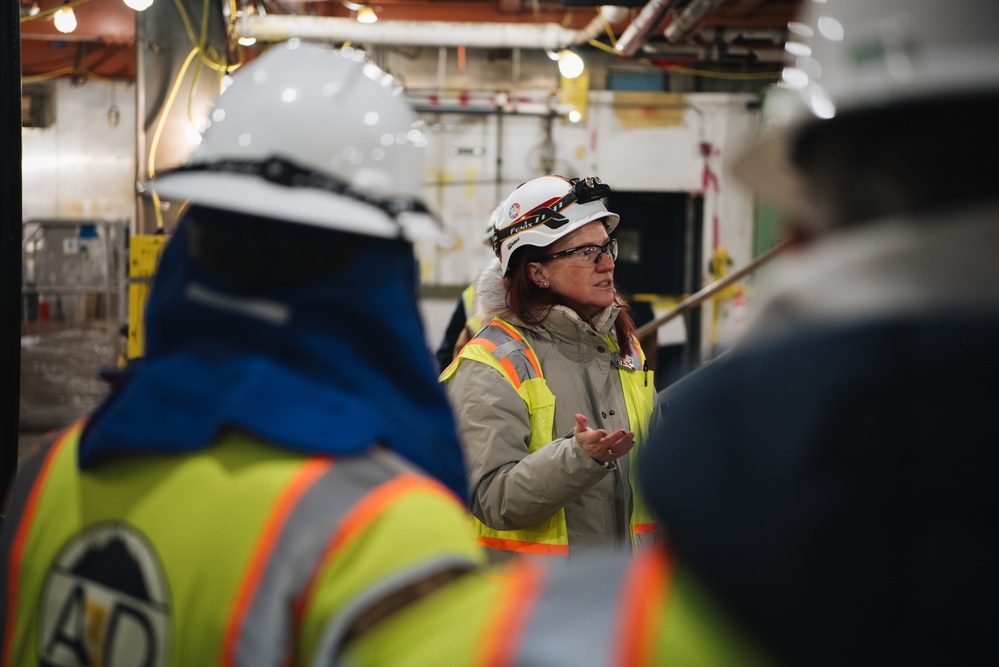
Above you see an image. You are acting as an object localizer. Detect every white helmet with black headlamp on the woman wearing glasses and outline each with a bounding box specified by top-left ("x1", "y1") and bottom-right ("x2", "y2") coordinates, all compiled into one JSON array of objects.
[{"x1": 493, "y1": 176, "x2": 621, "y2": 275}]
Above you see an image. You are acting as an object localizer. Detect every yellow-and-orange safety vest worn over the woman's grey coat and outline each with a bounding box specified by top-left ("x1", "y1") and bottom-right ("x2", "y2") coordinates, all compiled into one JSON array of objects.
[{"x1": 440, "y1": 318, "x2": 659, "y2": 556}]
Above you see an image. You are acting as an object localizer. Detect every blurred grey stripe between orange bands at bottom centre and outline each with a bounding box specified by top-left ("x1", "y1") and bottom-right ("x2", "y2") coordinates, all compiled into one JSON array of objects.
[{"x1": 513, "y1": 551, "x2": 632, "y2": 667}]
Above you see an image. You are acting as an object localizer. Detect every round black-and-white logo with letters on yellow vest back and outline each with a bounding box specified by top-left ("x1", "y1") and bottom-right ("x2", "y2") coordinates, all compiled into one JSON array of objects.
[{"x1": 38, "y1": 523, "x2": 170, "y2": 667}]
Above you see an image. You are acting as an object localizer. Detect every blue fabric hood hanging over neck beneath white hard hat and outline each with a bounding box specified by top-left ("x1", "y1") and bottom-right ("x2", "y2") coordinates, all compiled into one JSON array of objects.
[{"x1": 80, "y1": 209, "x2": 467, "y2": 501}]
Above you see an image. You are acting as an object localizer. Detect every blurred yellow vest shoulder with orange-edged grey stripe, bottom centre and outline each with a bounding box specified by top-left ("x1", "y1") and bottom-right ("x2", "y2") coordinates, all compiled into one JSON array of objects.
[{"x1": 346, "y1": 549, "x2": 779, "y2": 667}]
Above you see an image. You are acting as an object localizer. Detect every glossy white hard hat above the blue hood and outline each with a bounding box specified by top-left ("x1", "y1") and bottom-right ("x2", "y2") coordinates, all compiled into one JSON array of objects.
[{"x1": 152, "y1": 39, "x2": 440, "y2": 239}]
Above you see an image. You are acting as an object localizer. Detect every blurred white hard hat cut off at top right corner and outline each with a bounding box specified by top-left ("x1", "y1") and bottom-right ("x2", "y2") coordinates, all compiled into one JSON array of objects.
[{"x1": 733, "y1": 0, "x2": 999, "y2": 210}]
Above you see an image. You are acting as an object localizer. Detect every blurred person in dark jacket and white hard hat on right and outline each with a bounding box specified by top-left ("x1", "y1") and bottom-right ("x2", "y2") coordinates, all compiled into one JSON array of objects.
[{"x1": 639, "y1": 0, "x2": 999, "y2": 665}]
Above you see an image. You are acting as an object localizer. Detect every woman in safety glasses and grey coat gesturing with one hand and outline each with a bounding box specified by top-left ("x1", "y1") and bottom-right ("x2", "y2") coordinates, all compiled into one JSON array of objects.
[{"x1": 441, "y1": 176, "x2": 658, "y2": 560}]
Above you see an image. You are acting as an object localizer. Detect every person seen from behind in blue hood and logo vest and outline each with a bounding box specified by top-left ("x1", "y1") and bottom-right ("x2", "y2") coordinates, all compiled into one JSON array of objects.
[{"x1": 0, "y1": 40, "x2": 486, "y2": 666}]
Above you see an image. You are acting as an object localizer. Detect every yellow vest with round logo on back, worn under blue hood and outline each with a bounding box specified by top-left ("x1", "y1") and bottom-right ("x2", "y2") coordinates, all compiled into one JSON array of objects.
[{"x1": 0, "y1": 424, "x2": 485, "y2": 666}]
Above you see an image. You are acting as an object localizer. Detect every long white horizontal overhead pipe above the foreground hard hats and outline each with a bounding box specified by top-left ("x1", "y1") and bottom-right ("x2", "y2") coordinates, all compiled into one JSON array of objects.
[{"x1": 236, "y1": 14, "x2": 603, "y2": 51}]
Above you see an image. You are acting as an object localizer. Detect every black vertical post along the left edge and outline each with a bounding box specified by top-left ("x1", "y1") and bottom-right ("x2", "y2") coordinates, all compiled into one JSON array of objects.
[{"x1": 0, "y1": 2, "x2": 22, "y2": 499}]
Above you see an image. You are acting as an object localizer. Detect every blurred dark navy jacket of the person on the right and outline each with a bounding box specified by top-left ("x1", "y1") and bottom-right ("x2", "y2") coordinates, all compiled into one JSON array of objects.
[{"x1": 638, "y1": 313, "x2": 999, "y2": 665}]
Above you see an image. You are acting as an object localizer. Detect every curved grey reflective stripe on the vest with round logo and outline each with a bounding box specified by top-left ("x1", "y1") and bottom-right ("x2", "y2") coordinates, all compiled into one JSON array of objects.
[{"x1": 236, "y1": 450, "x2": 411, "y2": 665}]
